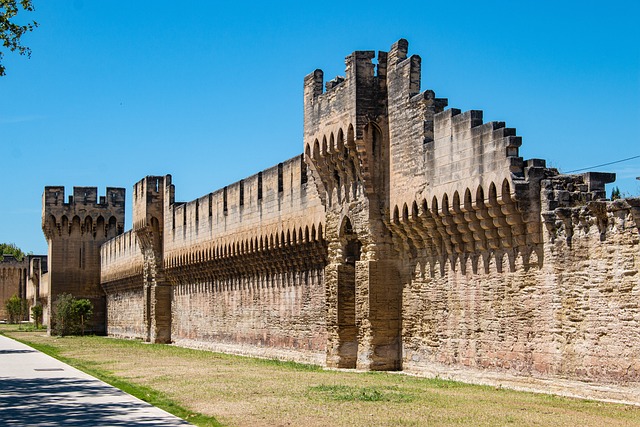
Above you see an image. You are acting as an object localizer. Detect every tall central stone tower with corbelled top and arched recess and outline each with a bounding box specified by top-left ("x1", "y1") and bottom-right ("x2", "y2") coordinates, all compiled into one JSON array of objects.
[{"x1": 304, "y1": 40, "x2": 402, "y2": 370}]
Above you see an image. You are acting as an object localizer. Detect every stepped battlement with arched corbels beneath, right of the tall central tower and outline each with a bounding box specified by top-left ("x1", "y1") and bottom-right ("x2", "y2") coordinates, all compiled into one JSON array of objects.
[{"x1": 385, "y1": 40, "x2": 545, "y2": 274}]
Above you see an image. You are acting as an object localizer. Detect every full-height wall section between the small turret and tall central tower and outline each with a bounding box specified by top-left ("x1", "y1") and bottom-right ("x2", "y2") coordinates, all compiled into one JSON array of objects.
[{"x1": 165, "y1": 157, "x2": 325, "y2": 361}]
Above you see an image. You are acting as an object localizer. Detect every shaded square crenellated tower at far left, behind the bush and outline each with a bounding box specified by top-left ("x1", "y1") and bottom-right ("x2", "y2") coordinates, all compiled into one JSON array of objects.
[{"x1": 42, "y1": 186, "x2": 125, "y2": 334}]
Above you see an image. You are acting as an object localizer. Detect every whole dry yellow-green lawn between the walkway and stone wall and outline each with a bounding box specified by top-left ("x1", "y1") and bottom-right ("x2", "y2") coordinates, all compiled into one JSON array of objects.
[{"x1": 0, "y1": 325, "x2": 640, "y2": 427}]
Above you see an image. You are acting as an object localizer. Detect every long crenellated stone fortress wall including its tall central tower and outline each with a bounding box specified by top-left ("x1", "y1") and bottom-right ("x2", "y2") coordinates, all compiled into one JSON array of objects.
[{"x1": 43, "y1": 40, "x2": 640, "y2": 402}]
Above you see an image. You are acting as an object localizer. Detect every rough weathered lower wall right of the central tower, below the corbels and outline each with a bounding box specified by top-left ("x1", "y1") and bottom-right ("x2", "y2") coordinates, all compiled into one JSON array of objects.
[{"x1": 403, "y1": 176, "x2": 640, "y2": 402}]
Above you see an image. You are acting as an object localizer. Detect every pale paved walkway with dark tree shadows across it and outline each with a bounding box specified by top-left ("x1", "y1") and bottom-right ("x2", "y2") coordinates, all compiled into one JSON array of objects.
[{"x1": 0, "y1": 335, "x2": 191, "y2": 427}]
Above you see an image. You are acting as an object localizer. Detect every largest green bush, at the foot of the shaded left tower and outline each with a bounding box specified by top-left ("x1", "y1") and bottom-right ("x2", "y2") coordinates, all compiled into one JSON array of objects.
[{"x1": 51, "y1": 294, "x2": 93, "y2": 336}]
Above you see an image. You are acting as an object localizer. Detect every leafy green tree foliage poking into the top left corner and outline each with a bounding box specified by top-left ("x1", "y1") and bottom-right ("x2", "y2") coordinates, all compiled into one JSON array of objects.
[{"x1": 0, "y1": 0, "x2": 38, "y2": 76}]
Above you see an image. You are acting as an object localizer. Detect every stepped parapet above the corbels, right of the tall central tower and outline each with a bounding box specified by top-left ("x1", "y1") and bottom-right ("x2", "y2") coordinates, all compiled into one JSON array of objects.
[{"x1": 387, "y1": 40, "x2": 524, "y2": 214}]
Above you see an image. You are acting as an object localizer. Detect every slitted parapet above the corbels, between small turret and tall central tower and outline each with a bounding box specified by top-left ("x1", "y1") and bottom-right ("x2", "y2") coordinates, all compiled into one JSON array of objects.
[{"x1": 164, "y1": 156, "x2": 323, "y2": 266}]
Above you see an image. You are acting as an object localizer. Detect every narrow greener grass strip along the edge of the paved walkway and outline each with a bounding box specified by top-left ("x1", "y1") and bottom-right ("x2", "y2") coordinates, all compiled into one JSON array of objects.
[{"x1": 5, "y1": 331, "x2": 222, "y2": 427}]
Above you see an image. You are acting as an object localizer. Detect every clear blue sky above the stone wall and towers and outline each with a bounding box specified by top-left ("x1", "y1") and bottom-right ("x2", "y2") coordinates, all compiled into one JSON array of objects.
[{"x1": 0, "y1": 0, "x2": 640, "y2": 253}]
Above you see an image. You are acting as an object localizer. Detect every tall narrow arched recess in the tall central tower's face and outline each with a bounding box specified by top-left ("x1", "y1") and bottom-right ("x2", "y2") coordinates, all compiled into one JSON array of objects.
[{"x1": 338, "y1": 218, "x2": 362, "y2": 368}]
